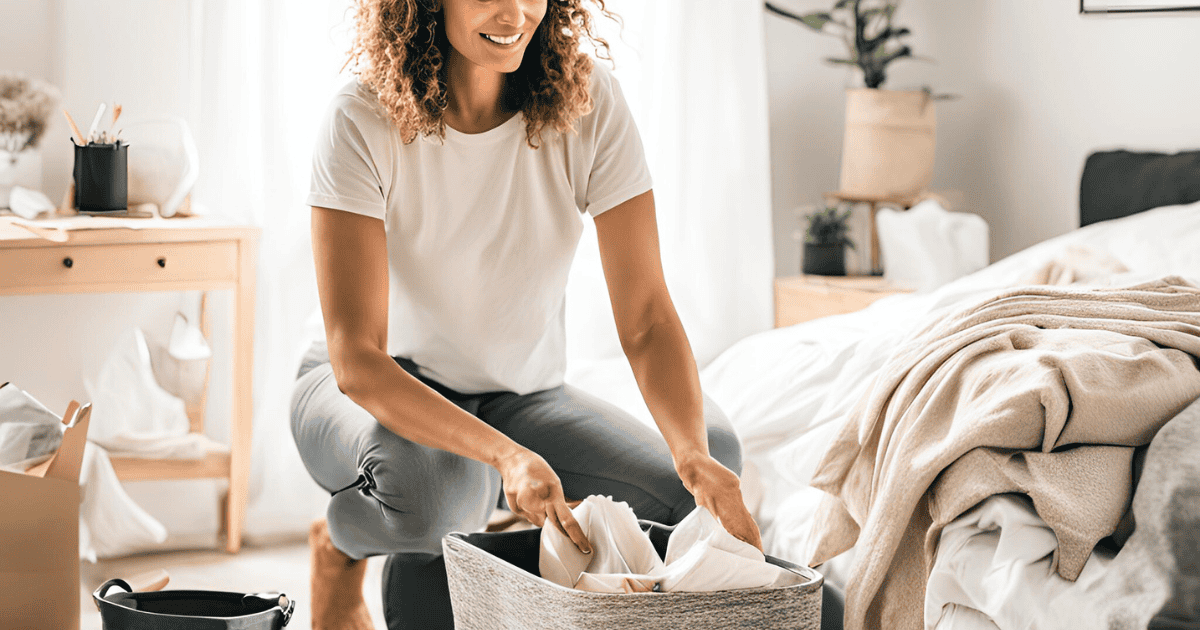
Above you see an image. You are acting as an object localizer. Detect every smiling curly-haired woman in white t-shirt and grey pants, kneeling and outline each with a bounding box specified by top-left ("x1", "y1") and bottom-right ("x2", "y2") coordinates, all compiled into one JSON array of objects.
[{"x1": 292, "y1": 0, "x2": 762, "y2": 629}]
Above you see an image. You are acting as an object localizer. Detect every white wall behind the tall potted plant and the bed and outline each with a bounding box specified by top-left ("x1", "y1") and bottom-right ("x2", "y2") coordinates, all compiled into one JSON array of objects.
[{"x1": 767, "y1": 0, "x2": 1200, "y2": 275}]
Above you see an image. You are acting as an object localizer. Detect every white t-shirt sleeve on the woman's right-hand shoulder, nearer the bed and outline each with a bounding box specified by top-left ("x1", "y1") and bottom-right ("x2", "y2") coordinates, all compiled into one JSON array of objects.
[{"x1": 581, "y1": 64, "x2": 653, "y2": 217}]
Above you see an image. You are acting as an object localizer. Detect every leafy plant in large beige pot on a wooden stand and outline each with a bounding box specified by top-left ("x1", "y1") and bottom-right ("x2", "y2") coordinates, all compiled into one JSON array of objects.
[{"x1": 767, "y1": 0, "x2": 949, "y2": 198}]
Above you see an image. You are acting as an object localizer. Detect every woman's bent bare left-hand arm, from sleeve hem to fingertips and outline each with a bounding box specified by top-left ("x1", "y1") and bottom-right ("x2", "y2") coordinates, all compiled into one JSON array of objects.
[{"x1": 312, "y1": 206, "x2": 590, "y2": 551}]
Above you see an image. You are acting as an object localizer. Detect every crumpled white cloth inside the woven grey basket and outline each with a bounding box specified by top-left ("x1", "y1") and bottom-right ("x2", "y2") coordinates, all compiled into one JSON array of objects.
[{"x1": 538, "y1": 494, "x2": 803, "y2": 593}]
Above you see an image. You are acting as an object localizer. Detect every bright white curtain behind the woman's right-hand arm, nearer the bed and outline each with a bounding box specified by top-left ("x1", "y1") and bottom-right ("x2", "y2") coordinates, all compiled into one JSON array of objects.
[{"x1": 566, "y1": 0, "x2": 774, "y2": 422}]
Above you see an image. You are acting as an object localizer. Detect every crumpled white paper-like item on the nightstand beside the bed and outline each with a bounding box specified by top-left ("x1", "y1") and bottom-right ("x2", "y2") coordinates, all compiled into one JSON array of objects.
[{"x1": 875, "y1": 199, "x2": 989, "y2": 293}]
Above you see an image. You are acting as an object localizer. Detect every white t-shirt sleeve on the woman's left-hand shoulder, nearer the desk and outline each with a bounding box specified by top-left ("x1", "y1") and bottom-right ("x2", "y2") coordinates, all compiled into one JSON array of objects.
[{"x1": 307, "y1": 92, "x2": 391, "y2": 220}]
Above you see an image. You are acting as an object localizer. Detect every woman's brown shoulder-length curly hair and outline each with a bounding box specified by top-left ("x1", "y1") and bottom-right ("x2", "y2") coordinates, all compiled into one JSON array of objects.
[{"x1": 343, "y1": 0, "x2": 619, "y2": 149}]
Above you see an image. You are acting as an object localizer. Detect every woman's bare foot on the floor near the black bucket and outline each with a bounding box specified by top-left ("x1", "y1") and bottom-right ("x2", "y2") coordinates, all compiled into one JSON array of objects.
[{"x1": 308, "y1": 518, "x2": 374, "y2": 630}]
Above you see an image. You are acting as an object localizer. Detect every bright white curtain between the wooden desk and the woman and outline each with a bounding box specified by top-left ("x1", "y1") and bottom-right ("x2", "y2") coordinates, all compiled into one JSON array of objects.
[{"x1": 192, "y1": 0, "x2": 352, "y2": 541}]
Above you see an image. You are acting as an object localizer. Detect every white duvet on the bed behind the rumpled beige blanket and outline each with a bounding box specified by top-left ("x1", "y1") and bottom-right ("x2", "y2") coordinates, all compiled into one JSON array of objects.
[{"x1": 568, "y1": 198, "x2": 1200, "y2": 630}]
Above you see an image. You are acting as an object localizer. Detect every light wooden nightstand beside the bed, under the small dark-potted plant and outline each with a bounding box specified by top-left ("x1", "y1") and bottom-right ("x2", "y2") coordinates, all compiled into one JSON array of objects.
[{"x1": 775, "y1": 276, "x2": 910, "y2": 328}]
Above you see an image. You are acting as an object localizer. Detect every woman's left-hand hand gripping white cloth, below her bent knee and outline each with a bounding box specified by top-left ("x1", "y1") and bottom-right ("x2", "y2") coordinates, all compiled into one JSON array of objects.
[{"x1": 497, "y1": 449, "x2": 592, "y2": 553}]
